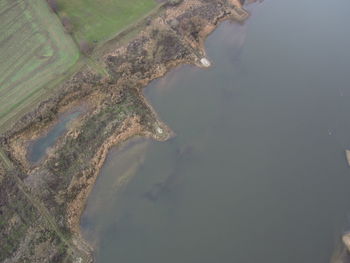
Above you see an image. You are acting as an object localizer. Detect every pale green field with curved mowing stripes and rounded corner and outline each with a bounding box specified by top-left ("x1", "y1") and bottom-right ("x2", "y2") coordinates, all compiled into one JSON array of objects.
[{"x1": 0, "y1": 0, "x2": 79, "y2": 130}]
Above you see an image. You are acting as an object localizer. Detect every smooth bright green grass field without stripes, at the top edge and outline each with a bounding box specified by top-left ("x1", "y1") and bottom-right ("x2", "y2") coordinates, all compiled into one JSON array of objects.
[{"x1": 57, "y1": 0, "x2": 157, "y2": 42}]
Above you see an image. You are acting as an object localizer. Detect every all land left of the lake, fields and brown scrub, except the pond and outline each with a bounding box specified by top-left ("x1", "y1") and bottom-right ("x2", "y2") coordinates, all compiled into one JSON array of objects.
[{"x1": 0, "y1": 0, "x2": 252, "y2": 263}]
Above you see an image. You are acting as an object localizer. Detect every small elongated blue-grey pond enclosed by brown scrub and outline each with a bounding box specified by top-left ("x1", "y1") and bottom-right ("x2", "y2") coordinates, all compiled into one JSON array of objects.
[{"x1": 28, "y1": 111, "x2": 81, "y2": 163}]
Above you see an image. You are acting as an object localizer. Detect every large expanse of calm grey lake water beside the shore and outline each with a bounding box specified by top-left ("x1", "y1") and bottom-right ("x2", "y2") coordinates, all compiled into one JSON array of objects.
[{"x1": 82, "y1": 0, "x2": 350, "y2": 263}]
